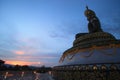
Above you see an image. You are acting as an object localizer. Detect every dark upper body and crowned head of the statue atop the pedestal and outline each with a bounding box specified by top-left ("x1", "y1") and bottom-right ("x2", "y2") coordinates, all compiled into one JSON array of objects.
[{"x1": 85, "y1": 6, "x2": 103, "y2": 33}]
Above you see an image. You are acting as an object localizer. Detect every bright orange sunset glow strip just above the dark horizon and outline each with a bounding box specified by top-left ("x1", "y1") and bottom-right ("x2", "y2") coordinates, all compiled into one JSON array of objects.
[{"x1": 5, "y1": 60, "x2": 42, "y2": 65}]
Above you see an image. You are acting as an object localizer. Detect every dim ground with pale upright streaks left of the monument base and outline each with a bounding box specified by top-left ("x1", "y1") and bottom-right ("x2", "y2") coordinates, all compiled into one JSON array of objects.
[{"x1": 0, "y1": 71, "x2": 53, "y2": 80}]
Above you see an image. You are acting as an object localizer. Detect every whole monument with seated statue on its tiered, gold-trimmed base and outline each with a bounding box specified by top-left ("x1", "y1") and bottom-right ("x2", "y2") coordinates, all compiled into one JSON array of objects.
[{"x1": 53, "y1": 7, "x2": 120, "y2": 80}]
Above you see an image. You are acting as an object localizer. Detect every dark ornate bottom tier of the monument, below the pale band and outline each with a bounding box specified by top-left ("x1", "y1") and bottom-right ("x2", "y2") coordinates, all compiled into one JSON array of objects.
[{"x1": 52, "y1": 64, "x2": 120, "y2": 80}]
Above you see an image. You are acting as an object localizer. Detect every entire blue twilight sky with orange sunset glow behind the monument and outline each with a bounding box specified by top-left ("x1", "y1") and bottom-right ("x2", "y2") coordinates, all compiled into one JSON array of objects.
[{"x1": 0, "y1": 0, "x2": 120, "y2": 66}]
